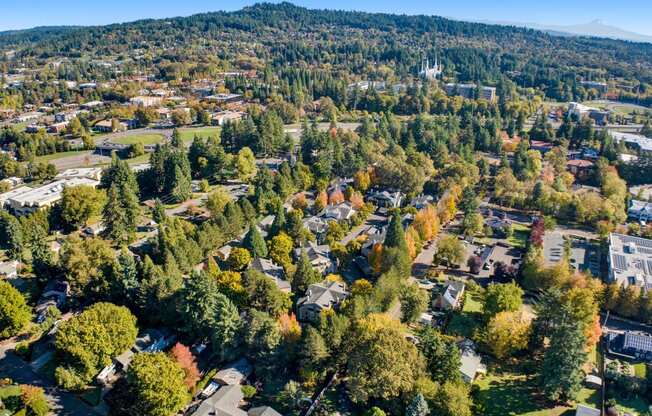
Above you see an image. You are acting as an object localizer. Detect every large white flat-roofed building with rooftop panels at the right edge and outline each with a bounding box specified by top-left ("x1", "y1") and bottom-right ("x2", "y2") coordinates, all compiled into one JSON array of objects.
[{"x1": 609, "y1": 233, "x2": 652, "y2": 290}]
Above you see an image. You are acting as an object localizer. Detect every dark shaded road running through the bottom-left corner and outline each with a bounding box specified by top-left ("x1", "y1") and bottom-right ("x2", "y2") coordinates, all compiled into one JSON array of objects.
[{"x1": 0, "y1": 342, "x2": 100, "y2": 416}]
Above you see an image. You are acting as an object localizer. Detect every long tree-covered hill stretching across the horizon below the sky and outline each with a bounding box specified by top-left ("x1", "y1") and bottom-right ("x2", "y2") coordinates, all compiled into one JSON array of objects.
[{"x1": 0, "y1": 3, "x2": 652, "y2": 95}]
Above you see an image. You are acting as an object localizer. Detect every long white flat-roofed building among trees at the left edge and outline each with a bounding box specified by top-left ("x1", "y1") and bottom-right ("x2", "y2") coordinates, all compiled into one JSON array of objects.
[{"x1": 0, "y1": 177, "x2": 100, "y2": 215}]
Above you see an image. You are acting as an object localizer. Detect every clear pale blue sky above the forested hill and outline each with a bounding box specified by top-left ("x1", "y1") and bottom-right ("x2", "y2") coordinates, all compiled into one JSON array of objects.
[{"x1": 0, "y1": 0, "x2": 652, "y2": 35}]
